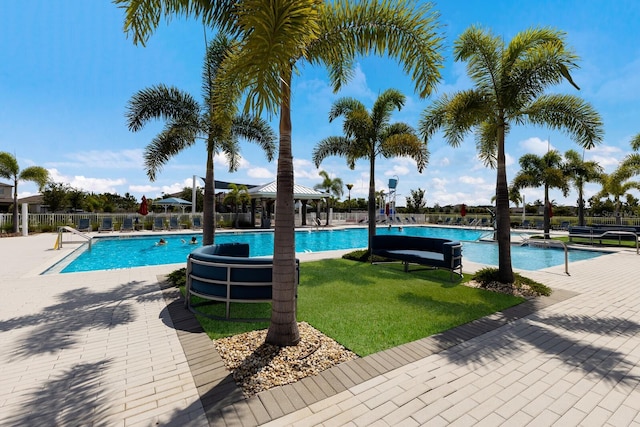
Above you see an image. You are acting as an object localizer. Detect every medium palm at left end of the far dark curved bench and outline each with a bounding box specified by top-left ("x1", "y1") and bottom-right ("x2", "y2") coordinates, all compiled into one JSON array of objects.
[{"x1": 312, "y1": 89, "x2": 429, "y2": 251}]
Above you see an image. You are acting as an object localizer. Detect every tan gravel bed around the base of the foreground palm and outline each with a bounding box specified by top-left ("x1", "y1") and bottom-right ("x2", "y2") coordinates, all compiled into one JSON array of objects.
[{"x1": 213, "y1": 322, "x2": 358, "y2": 397}]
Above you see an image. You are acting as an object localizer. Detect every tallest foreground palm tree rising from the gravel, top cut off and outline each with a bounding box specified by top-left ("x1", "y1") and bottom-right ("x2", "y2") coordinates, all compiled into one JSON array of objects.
[{"x1": 114, "y1": 0, "x2": 442, "y2": 346}]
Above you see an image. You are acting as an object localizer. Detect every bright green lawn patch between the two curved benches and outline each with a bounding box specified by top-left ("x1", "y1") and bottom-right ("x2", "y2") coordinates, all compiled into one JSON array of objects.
[{"x1": 194, "y1": 259, "x2": 524, "y2": 356}]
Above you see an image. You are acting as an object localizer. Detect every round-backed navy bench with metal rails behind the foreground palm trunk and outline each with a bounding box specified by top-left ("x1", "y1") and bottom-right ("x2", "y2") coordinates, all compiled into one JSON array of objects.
[{"x1": 185, "y1": 243, "x2": 300, "y2": 320}]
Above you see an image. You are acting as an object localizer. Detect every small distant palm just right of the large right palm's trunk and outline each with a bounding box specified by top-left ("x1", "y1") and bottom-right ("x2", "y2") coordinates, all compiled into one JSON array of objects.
[{"x1": 511, "y1": 150, "x2": 569, "y2": 239}]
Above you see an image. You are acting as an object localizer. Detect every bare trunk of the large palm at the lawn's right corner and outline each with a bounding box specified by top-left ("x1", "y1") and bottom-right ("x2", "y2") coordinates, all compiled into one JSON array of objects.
[{"x1": 496, "y1": 121, "x2": 513, "y2": 283}]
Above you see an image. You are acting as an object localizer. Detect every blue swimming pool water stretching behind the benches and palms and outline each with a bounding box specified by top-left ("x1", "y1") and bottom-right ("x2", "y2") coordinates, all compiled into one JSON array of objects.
[{"x1": 53, "y1": 227, "x2": 603, "y2": 273}]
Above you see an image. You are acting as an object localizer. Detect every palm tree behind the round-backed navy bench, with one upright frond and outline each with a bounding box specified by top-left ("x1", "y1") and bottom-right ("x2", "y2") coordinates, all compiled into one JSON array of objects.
[{"x1": 127, "y1": 35, "x2": 276, "y2": 245}]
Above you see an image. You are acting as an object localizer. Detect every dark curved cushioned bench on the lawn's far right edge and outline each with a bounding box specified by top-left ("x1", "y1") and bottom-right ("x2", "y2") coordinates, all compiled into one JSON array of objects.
[{"x1": 371, "y1": 235, "x2": 462, "y2": 278}]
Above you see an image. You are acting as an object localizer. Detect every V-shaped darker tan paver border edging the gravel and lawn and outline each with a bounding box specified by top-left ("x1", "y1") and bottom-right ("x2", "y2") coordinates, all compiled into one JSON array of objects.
[{"x1": 157, "y1": 276, "x2": 579, "y2": 425}]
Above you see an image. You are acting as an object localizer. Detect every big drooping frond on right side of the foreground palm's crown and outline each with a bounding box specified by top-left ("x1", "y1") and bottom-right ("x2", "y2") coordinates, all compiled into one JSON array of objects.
[{"x1": 312, "y1": 0, "x2": 443, "y2": 97}]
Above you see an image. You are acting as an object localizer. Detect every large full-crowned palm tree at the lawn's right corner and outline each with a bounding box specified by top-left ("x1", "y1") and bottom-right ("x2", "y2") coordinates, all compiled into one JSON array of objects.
[{"x1": 420, "y1": 26, "x2": 603, "y2": 283}]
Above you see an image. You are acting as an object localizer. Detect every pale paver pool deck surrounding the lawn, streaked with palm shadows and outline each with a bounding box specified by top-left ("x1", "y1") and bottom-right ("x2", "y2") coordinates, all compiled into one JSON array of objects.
[{"x1": 0, "y1": 234, "x2": 640, "y2": 426}]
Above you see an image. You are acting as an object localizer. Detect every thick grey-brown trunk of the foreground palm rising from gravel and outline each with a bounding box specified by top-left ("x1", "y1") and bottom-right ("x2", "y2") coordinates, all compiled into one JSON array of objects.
[{"x1": 266, "y1": 70, "x2": 300, "y2": 346}]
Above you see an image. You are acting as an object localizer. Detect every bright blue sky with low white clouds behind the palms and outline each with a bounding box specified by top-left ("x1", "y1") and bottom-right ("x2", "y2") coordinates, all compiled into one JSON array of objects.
[{"x1": 0, "y1": 0, "x2": 640, "y2": 206}]
